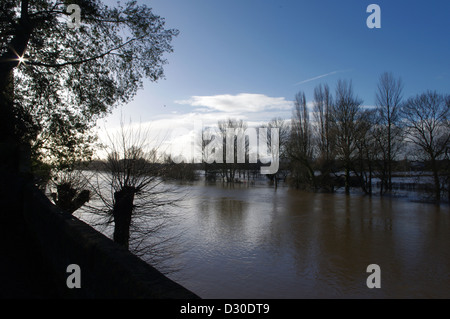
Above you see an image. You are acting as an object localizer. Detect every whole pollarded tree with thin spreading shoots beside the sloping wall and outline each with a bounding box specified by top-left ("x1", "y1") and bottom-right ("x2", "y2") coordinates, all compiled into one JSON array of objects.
[{"x1": 89, "y1": 123, "x2": 181, "y2": 272}]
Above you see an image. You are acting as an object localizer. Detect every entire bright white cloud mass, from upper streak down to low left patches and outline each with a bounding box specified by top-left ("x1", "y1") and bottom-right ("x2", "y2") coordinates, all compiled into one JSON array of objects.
[{"x1": 99, "y1": 93, "x2": 293, "y2": 161}]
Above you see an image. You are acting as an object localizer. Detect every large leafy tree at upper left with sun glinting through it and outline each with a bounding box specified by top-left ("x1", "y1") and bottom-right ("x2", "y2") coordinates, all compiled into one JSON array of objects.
[{"x1": 0, "y1": 0, "x2": 178, "y2": 170}]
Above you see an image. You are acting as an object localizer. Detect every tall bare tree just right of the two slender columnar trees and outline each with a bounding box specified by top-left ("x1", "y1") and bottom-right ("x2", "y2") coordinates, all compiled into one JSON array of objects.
[{"x1": 332, "y1": 80, "x2": 362, "y2": 194}]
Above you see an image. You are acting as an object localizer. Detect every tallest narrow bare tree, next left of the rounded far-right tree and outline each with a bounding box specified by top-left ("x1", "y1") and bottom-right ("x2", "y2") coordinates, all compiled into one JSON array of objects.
[{"x1": 376, "y1": 72, "x2": 403, "y2": 193}]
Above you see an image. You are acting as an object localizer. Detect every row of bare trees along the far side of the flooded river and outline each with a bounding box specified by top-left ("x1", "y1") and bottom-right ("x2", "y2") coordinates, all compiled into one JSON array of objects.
[{"x1": 156, "y1": 72, "x2": 450, "y2": 201}]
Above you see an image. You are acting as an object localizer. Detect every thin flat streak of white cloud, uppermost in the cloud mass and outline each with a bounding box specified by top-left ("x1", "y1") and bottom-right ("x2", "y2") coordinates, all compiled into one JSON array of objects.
[{"x1": 175, "y1": 93, "x2": 292, "y2": 113}]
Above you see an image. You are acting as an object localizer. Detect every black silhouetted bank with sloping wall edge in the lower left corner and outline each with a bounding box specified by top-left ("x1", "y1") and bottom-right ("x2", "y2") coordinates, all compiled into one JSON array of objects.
[{"x1": 0, "y1": 173, "x2": 198, "y2": 299}]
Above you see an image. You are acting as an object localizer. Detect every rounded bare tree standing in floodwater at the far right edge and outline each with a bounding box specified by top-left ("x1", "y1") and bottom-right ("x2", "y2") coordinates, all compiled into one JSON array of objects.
[{"x1": 402, "y1": 91, "x2": 450, "y2": 201}]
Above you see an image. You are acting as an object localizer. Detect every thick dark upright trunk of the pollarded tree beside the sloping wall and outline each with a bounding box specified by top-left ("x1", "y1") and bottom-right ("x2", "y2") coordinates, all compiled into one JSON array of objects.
[{"x1": 113, "y1": 186, "x2": 136, "y2": 249}]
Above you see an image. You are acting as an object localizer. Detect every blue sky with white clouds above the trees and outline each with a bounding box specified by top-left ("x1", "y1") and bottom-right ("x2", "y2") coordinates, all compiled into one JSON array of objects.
[{"x1": 98, "y1": 0, "x2": 450, "y2": 153}]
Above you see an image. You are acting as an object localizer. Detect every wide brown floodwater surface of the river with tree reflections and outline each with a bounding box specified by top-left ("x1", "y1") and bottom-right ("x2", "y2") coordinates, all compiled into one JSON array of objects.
[{"x1": 77, "y1": 182, "x2": 450, "y2": 298}]
